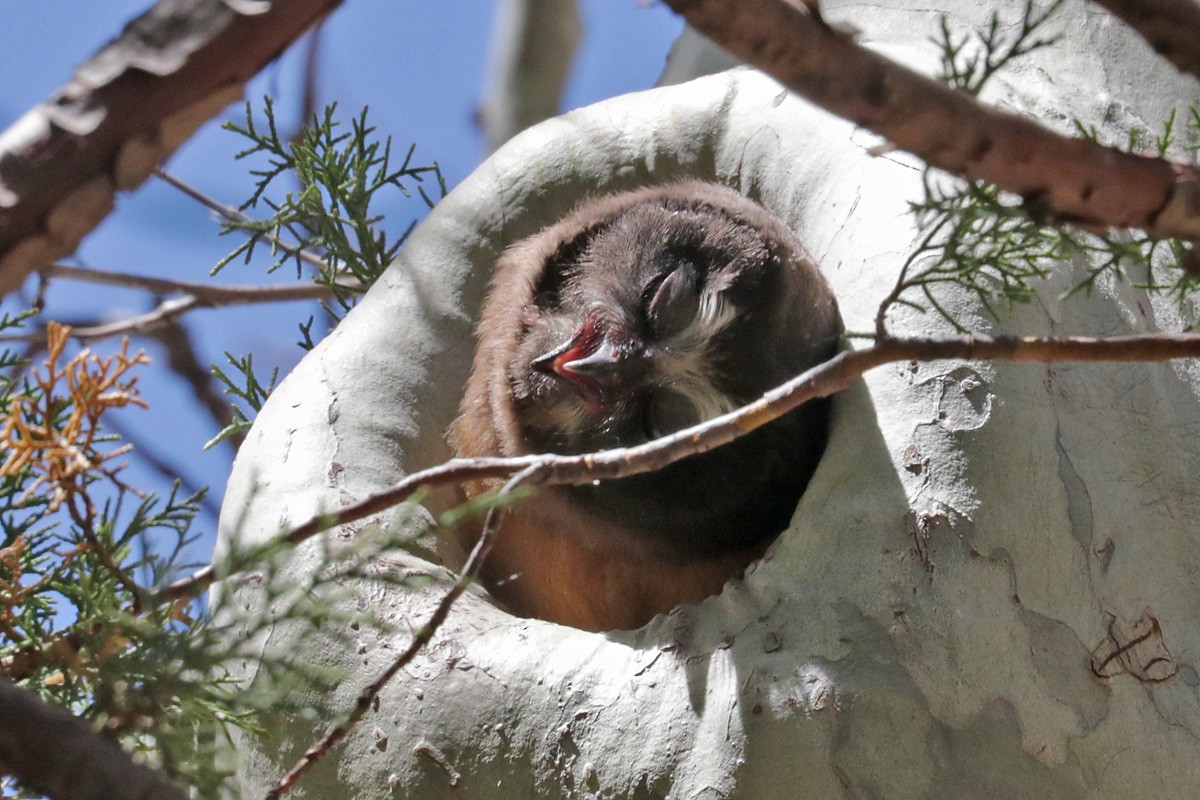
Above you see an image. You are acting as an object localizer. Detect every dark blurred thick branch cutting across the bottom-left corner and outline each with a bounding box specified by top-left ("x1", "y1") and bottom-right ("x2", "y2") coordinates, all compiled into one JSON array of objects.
[{"x1": 0, "y1": 676, "x2": 187, "y2": 800}]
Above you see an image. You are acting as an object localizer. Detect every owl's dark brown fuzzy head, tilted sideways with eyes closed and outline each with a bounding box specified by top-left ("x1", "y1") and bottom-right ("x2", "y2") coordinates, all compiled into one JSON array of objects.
[{"x1": 508, "y1": 184, "x2": 838, "y2": 453}]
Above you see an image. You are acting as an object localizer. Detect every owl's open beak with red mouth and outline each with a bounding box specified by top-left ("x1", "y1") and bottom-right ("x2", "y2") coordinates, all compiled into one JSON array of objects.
[{"x1": 529, "y1": 312, "x2": 646, "y2": 414}]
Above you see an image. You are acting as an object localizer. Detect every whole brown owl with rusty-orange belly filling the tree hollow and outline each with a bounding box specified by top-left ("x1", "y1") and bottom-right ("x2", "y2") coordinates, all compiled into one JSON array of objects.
[{"x1": 451, "y1": 181, "x2": 841, "y2": 630}]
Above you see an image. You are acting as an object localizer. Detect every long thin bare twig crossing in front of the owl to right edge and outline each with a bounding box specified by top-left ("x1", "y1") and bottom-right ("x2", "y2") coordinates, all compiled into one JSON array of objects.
[{"x1": 156, "y1": 333, "x2": 1200, "y2": 602}]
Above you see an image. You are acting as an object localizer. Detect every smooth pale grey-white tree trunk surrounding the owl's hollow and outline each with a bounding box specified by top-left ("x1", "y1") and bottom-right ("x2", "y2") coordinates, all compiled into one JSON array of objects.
[{"x1": 222, "y1": 1, "x2": 1200, "y2": 800}]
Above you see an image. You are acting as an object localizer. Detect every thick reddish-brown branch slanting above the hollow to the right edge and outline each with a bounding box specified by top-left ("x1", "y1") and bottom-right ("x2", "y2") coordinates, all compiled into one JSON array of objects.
[{"x1": 665, "y1": 0, "x2": 1200, "y2": 240}]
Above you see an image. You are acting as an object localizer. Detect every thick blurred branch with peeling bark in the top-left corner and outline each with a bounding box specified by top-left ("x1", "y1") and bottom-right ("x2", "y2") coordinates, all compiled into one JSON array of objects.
[{"x1": 0, "y1": 0, "x2": 340, "y2": 293}]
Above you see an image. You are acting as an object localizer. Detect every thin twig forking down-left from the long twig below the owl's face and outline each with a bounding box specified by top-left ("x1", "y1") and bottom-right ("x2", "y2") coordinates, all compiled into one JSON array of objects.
[{"x1": 266, "y1": 463, "x2": 546, "y2": 800}]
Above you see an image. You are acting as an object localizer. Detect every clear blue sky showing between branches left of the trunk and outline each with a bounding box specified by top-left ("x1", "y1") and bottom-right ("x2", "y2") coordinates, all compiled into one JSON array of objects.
[{"x1": 0, "y1": 0, "x2": 682, "y2": 556}]
